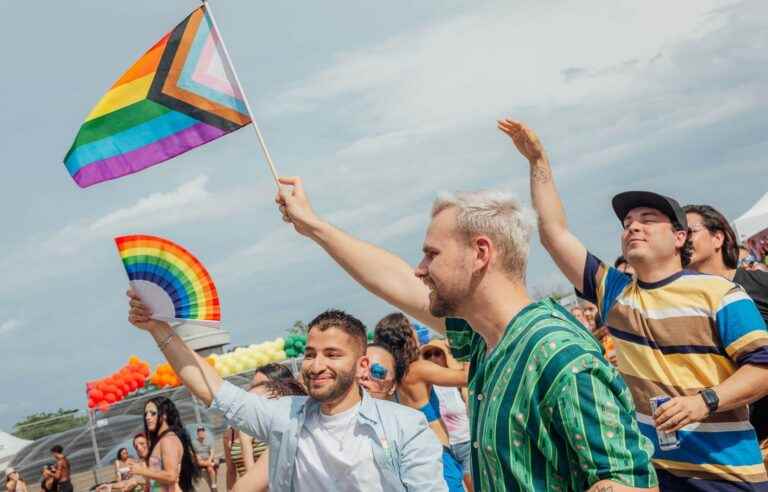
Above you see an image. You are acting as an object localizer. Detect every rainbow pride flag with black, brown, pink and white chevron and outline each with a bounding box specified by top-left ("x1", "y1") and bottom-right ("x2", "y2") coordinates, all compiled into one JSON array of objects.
[{"x1": 64, "y1": 6, "x2": 251, "y2": 188}]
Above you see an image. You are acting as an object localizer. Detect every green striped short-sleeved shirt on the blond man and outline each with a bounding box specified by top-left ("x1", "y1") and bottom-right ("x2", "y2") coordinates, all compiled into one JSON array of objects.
[{"x1": 446, "y1": 299, "x2": 657, "y2": 491}]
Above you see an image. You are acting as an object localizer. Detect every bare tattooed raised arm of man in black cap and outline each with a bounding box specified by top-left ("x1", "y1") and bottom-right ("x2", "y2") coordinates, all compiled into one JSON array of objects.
[{"x1": 499, "y1": 119, "x2": 587, "y2": 291}]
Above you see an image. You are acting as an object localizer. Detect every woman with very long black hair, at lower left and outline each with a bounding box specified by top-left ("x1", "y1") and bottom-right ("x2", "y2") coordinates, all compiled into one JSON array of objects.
[{"x1": 131, "y1": 396, "x2": 200, "y2": 492}]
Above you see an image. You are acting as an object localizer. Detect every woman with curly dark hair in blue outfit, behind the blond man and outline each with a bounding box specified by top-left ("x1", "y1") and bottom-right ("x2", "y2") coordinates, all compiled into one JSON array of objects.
[{"x1": 373, "y1": 313, "x2": 468, "y2": 492}]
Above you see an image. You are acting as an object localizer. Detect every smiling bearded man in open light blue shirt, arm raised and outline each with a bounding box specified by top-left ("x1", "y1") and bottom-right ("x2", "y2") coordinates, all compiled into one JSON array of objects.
[{"x1": 128, "y1": 291, "x2": 446, "y2": 492}]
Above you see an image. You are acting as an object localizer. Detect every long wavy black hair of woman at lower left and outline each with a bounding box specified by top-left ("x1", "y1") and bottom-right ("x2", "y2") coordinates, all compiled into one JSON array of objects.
[{"x1": 144, "y1": 396, "x2": 200, "y2": 492}]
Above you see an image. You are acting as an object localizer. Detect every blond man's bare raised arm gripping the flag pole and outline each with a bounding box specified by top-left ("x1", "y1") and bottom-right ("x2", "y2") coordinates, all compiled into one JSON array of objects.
[{"x1": 275, "y1": 177, "x2": 445, "y2": 333}]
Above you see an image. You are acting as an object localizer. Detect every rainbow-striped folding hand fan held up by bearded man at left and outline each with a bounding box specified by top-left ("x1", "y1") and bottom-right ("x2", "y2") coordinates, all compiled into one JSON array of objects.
[{"x1": 115, "y1": 234, "x2": 221, "y2": 327}]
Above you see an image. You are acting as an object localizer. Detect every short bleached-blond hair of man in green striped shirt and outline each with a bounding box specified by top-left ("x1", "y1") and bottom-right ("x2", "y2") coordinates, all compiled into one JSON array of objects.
[{"x1": 432, "y1": 190, "x2": 536, "y2": 279}]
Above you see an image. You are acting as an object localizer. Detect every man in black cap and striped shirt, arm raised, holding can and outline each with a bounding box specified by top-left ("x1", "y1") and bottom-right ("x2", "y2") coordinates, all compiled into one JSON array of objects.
[{"x1": 499, "y1": 120, "x2": 768, "y2": 491}]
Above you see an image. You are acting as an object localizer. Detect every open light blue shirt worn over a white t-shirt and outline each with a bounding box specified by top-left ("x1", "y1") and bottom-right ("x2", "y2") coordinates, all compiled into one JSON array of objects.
[{"x1": 211, "y1": 382, "x2": 447, "y2": 492}]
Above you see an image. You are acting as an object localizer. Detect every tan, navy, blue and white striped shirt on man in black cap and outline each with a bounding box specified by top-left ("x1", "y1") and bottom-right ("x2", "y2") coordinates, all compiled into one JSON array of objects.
[{"x1": 582, "y1": 254, "x2": 768, "y2": 490}]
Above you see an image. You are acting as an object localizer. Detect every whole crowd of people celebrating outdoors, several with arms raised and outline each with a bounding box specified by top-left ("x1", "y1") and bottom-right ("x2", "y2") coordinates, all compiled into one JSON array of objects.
[{"x1": 6, "y1": 119, "x2": 768, "y2": 492}]
